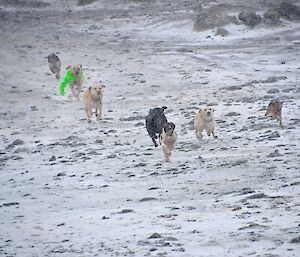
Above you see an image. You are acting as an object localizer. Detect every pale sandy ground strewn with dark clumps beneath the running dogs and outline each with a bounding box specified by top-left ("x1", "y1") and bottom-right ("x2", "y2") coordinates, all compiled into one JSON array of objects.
[{"x1": 0, "y1": 0, "x2": 300, "y2": 257}]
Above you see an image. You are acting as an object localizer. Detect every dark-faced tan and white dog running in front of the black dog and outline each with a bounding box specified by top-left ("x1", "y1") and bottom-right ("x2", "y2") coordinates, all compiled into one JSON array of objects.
[{"x1": 159, "y1": 122, "x2": 177, "y2": 162}]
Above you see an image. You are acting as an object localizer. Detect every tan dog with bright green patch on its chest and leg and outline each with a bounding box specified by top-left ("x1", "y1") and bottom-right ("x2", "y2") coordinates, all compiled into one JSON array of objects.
[{"x1": 59, "y1": 64, "x2": 84, "y2": 100}]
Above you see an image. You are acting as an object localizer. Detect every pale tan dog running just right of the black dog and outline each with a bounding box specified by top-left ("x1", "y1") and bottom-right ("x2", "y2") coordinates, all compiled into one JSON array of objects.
[{"x1": 194, "y1": 107, "x2": 218, "y2": 140}]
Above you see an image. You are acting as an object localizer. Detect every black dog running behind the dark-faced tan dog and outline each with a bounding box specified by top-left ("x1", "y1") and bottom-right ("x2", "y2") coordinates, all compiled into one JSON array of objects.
[{"x1": 146, "y1": 106, "x2": 168, "y2": 147}]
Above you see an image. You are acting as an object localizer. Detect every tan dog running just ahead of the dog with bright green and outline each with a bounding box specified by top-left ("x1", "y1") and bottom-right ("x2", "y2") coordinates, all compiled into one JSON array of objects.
[{"x1": 83, "y1": 83, "x2": 105, "y2": 123}]
